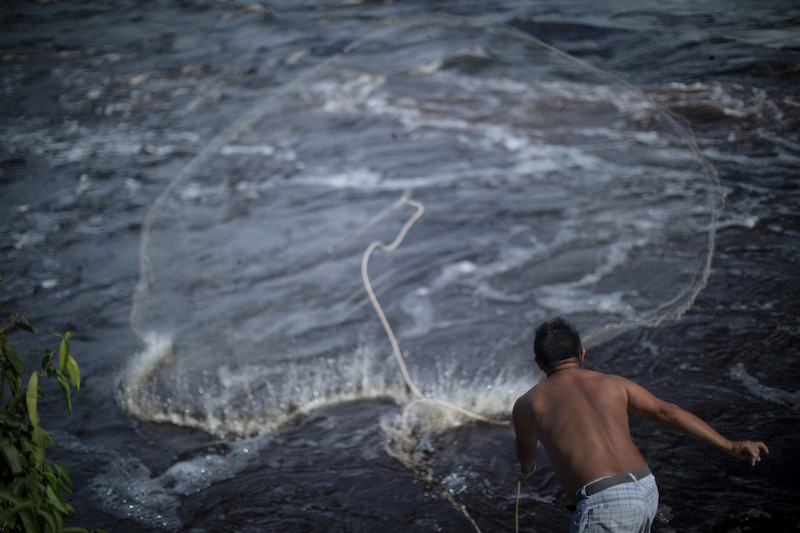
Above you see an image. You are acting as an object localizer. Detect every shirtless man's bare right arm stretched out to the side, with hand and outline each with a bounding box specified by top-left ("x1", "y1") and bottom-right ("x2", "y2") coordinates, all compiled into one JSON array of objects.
[{"x1": 625, "y1": 374, "x2": 769, "y2": 466}]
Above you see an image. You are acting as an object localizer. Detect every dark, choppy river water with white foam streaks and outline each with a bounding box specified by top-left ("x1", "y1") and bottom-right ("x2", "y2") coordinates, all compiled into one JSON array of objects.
[{"x1": 0, "y1": 0, "x2": 800, "y2": 532}]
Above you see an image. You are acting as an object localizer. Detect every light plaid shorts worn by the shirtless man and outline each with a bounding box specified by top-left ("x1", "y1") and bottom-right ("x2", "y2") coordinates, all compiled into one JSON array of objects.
[{"x1": 570, "y1": 474, "x2": 658, "y2": 533}]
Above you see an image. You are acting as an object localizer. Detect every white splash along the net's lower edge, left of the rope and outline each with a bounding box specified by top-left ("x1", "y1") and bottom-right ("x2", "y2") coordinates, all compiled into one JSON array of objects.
[{"x1": 117, "y1": 334, "x2": 407, "y2": 437}]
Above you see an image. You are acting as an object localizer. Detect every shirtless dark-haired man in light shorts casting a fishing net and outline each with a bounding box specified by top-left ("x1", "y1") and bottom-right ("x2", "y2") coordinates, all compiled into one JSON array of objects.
[{"x1": 513, "y1": 318, "x2": 769, "y2": 532}]
